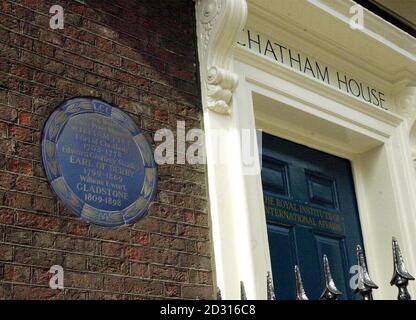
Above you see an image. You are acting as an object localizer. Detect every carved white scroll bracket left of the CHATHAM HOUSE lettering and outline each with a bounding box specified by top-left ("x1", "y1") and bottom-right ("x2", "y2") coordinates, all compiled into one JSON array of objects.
[{"x1": 196, "y1": 0, "x2": 247, "y2": 114}]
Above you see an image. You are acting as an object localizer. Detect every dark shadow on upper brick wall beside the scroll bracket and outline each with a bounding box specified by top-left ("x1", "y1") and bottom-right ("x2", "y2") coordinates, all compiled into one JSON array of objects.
[{"x1": 80, "y1": 0, "x2": 201, "y2": 108}]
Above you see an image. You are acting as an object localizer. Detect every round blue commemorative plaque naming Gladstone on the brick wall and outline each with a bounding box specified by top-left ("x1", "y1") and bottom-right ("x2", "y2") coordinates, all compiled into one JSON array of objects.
[{"x1": 42, "y1": 97, "x2": 157, "y2": 227}]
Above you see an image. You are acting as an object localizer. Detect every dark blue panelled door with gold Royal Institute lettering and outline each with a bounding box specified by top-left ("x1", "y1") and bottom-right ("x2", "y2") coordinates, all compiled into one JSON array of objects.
[{"x1": 262, "y1": 134, "x2": 362, "y2": 299}]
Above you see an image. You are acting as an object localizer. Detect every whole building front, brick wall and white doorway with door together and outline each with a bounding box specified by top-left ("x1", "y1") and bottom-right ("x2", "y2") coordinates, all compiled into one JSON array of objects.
[{"x1": 0, "y1": 0, "x2": 416, "y2": 299}]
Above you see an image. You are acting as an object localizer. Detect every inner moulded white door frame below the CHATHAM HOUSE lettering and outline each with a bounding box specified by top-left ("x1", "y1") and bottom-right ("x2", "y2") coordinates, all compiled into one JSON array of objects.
[{"x1": 210, "y1": 50, "x2": 416, "y2": 299}]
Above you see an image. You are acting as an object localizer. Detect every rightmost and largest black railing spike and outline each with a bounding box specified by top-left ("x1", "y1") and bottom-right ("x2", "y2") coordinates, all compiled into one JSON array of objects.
[{"x1": 390, "y1": 237, "x2": 415, "y2": 300}]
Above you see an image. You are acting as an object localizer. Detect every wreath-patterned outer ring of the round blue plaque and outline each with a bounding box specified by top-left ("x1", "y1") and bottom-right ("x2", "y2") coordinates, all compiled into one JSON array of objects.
[{"x1": 41, "y1": 96, "x2": 157, "y2": 228}]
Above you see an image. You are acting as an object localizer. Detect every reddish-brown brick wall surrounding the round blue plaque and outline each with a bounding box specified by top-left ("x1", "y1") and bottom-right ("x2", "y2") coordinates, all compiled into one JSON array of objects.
[{"x1": 0, "y1": 0, "x2": 214, "y2": 299}]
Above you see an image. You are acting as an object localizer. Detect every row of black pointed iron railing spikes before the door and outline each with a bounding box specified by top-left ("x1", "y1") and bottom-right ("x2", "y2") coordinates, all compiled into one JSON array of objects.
[{"x1": 217, "y1": 237, "x2": 415, "y2": 300}]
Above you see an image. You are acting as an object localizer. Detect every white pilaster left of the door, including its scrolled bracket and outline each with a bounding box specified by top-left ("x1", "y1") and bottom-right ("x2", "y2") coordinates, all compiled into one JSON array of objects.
[{"x1": 196, "y1": 0, "x2": 267, "y2": 299}]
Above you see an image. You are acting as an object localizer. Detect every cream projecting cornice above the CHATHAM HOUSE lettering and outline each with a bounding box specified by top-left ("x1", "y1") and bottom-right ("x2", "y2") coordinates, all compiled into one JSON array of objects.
[{"x1": 248, "y1": 0, "x2": 416, "y2": 87}]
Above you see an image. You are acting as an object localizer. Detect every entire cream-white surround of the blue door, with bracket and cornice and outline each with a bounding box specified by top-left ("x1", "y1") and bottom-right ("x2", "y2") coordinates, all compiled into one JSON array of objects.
[{"x1": 195, "y1": 0, "x2": 416, "y2": 299}]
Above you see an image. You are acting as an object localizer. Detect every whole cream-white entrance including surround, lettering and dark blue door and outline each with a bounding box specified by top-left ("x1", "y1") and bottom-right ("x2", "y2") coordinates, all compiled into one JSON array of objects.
[{"x1": 197, "y1": 0, "x2": 416, "y2": 299}]
